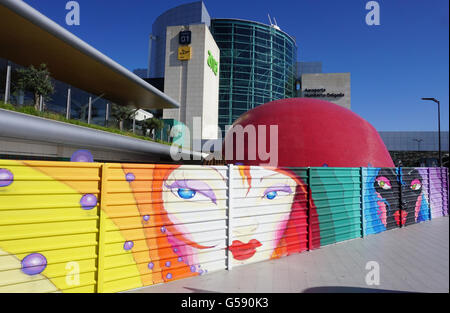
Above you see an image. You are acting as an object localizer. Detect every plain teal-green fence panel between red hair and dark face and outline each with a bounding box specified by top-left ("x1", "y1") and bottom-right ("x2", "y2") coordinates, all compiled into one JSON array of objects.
[{"x1": 309, "y1": 167, "x2": 362, "y2": 246}]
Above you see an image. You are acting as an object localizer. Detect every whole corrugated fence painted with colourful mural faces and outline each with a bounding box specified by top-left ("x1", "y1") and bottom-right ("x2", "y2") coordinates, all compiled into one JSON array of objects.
[{"x1": 0, "y1": 160, "x2": 449, "y2": 292}]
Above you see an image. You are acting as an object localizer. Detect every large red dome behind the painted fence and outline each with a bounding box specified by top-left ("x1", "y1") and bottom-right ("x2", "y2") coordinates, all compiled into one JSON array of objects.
[{"x1": 223, "y1": 98, "x2": 394, "y2": 167}]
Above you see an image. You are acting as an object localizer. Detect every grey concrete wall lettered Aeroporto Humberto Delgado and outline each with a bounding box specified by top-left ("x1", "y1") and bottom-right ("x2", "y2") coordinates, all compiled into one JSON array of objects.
[{"x1": 301, "y1": 73, "x2": 351, "y2": 109}]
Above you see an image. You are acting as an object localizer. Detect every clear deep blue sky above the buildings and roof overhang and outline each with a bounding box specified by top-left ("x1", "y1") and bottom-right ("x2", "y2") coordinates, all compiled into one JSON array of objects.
[{"x1": 25, "y1": 0, "x2": 449, "y2": 131}]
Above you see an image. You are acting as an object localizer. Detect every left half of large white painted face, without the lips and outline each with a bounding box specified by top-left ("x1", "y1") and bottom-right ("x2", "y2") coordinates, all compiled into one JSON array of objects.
[{"x1": 163, "y1": 165, "x2": 227, "y2": 270}]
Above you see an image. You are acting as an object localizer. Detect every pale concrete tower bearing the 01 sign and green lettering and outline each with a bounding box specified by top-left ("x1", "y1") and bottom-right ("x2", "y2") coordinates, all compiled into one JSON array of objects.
[{"x1": 163, "y1": 24, "x2": 220, "y2": 139}]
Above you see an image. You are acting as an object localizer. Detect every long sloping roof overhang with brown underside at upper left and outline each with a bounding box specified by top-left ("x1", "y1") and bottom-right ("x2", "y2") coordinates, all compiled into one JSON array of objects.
[{"x1": 0, "y1": 0, "x2": 180, "y2": 109}]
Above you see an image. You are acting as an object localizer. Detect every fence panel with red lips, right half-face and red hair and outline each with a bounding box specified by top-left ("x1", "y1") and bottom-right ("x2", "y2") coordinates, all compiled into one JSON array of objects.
[{"x1": 228, "y1": 166, "x2": 309, "y2": 266}]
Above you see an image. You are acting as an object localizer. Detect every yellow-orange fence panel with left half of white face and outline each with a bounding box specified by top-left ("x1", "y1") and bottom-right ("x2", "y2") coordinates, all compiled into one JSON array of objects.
[{"x1": 99, "y1": 164, "x2": 228, "y2": 292}]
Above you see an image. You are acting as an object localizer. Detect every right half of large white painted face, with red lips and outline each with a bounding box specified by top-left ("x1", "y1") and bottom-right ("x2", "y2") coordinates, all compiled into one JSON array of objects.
[{"x1": 229, "y1": 167, "x2": 297, "y2": 264}]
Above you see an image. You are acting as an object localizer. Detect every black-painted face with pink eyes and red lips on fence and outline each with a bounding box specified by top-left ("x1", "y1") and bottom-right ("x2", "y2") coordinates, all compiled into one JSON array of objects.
[{"x1": 374, "y1": 168, "x2": 422, "y2": 225}]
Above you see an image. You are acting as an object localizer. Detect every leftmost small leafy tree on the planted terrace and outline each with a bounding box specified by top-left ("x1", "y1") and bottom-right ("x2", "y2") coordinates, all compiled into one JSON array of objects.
[{"x1": 16, "y1": 63, "x2": 55, "y2": 110}]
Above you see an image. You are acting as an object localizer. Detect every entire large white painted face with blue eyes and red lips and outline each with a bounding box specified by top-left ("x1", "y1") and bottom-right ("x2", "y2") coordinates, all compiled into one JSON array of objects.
[{"x1": 163, "y1": 166, "x2": 297, "y2": 264}]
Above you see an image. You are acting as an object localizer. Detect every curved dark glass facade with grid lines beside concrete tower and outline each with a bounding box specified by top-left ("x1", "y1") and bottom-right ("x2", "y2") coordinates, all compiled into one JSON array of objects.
[{"x1": 211, "y1": 19, "x2": 297, "y2": 132}]
